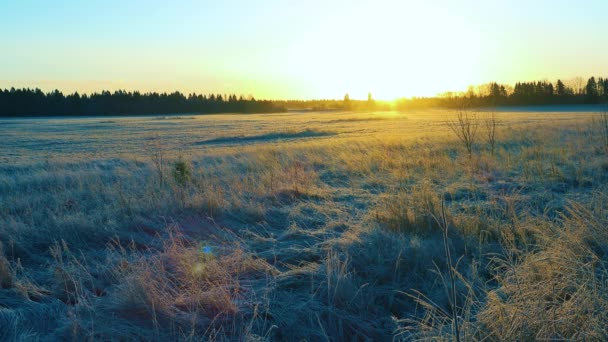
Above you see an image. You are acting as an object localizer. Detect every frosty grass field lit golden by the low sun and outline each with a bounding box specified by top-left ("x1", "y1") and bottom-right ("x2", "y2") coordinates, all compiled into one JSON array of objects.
[{"x1": 0, "y1": 110, "x2": 608, "y2": 341}]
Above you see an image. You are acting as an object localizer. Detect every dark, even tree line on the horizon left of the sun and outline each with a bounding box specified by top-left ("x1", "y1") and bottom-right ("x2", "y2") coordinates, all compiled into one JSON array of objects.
[{"x1": 0, "y1": 88, "x2": 286, "y2": 116}]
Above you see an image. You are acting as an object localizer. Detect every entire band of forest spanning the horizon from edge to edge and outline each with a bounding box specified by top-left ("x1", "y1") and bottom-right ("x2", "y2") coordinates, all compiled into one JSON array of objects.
[{"x1": 0, "y1": 77, "x2": 608, "y2": 117}]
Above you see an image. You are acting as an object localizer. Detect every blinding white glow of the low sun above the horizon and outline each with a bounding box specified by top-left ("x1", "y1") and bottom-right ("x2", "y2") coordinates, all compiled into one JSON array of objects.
[{"x1": 285, "y1": 2, "x2": 478, "y2": 100}]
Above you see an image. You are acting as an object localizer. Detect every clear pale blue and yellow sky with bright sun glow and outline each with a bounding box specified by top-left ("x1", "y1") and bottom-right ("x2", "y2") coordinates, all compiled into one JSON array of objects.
[{"x1": 0, "y1": 0, "x2": 608, "y2": 100}]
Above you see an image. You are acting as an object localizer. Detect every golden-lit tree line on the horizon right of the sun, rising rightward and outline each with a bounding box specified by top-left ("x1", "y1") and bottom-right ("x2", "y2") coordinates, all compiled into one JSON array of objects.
[{"x1": 396, "y1": 77, "x2": 608, "y2": 109}]
